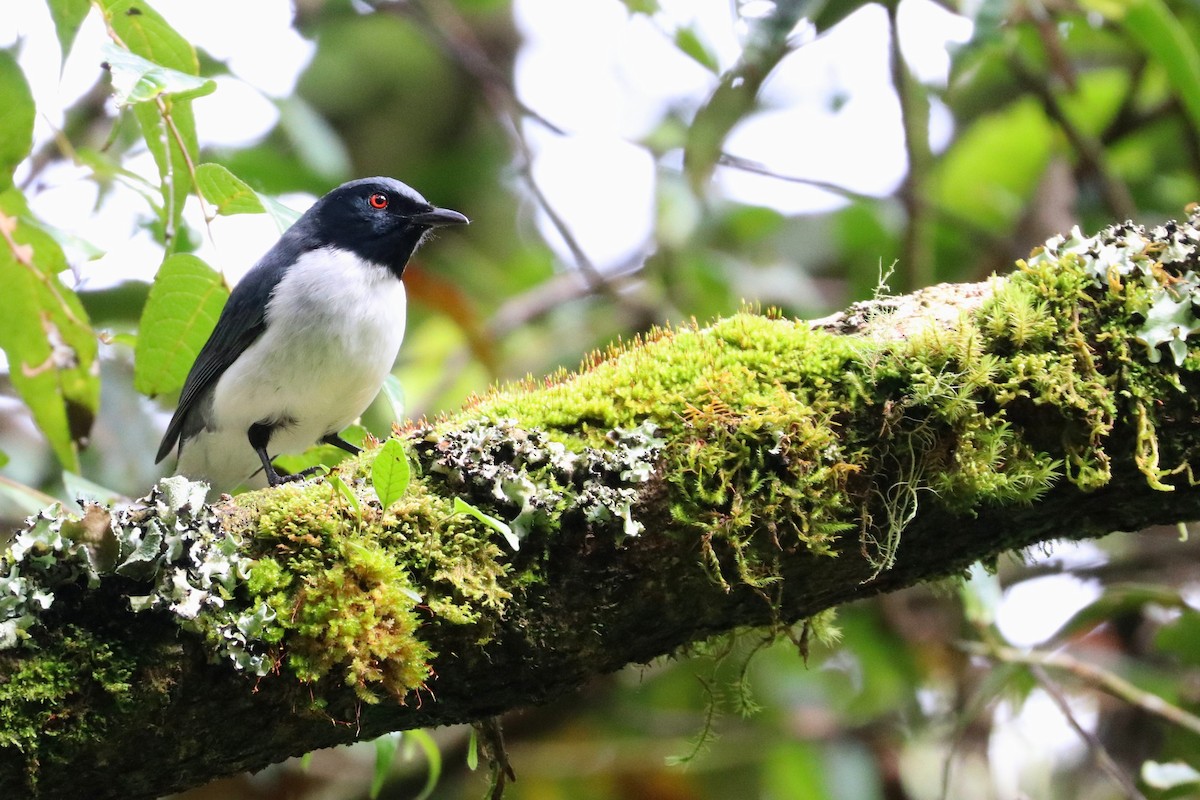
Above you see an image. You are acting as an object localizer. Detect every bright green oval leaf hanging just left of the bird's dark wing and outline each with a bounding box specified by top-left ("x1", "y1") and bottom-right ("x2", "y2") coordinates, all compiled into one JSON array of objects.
[{"x1": 133, "y1": 253, "x2": 229, "y2": 397}]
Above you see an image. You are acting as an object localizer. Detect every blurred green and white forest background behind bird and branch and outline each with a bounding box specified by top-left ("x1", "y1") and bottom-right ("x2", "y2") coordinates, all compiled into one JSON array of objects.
[{"x1": 7, "y1": 0, "x2": 1200, "y2": 800}]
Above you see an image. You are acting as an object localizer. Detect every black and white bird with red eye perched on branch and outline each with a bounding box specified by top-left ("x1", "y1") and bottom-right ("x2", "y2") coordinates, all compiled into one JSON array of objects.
[{"x1": 162, "y1": 178, "x2": 469, "y2": 491}]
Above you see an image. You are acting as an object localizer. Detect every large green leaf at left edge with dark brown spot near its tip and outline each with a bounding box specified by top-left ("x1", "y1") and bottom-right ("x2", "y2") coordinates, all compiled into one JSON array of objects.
[{"x1": 0, "y1": 190, "x2": 100, "y2": 471}]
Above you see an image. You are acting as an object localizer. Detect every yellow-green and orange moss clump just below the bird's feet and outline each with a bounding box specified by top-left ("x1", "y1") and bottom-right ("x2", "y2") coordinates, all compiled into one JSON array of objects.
[{"x1": 223, "y1": 475, "x2": 510, "y2": 702}]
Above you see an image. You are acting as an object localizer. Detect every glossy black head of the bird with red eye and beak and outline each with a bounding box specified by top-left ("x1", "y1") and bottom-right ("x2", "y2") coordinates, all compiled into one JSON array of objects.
[{"x1": 295, "y1": 178, "x2": 467, "y2": 277}]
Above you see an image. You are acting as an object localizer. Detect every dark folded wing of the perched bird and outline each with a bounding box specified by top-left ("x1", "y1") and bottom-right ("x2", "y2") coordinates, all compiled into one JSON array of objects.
[{"x1": 155, "y1": 244, "x2": 300, "y2": 463}]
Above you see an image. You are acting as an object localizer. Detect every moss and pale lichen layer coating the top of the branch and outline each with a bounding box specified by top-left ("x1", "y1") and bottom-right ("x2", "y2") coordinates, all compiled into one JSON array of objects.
[{"x1": 0, "y1": 208, "x2": 1200, "y2": 753}]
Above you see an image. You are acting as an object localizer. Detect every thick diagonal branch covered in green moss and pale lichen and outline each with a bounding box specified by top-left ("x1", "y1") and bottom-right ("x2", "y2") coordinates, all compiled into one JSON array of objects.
[{"x1": 7, "y1": 211, "x2": 1200, "y2": 798}]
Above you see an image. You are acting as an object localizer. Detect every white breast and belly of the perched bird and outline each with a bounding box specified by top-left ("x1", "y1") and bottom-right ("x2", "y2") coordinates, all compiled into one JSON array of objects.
[{"x1": 188, "y1": 247, "x2": 406, "y2": 482}]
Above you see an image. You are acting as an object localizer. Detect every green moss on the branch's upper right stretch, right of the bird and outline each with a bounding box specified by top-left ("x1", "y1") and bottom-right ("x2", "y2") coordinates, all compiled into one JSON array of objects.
[{"x1": 472, "y1": 212, "x2": 1200, "y2": 587}]
